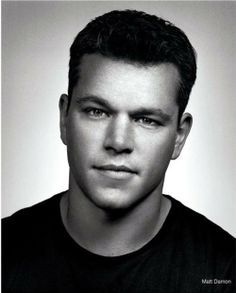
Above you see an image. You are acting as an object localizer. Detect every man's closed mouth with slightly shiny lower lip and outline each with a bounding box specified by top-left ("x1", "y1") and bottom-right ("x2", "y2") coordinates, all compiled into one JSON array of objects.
[{"x1": 93, "y1": 164, "x2": 137, "y2": 180}]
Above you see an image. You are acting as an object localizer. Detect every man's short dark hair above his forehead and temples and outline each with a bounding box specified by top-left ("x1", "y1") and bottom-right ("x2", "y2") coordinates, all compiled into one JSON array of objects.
[{"x1": 68, "y1": 10, "x2": 196, "y2": 117}]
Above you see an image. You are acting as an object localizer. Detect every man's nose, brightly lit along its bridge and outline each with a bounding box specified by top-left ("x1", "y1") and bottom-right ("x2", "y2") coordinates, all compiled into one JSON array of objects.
[{"x1": 104, "y1": 114, "x2": 134, "y2": 154}]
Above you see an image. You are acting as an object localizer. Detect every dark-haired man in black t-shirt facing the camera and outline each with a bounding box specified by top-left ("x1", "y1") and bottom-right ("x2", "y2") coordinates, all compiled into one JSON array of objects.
[{"x1": 3, "y1": 10, "x2": 235, "y2": 292}]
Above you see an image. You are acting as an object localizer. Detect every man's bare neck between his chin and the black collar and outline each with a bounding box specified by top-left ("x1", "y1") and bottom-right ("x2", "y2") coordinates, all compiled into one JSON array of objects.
[{"x1": 61, "y1": 175, "x2": 171, "y2": 256}]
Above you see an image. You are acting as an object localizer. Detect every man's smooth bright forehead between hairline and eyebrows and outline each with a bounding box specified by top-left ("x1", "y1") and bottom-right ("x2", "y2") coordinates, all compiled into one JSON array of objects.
[{"x1": 73, "y1": 54, "x2": 179, "y2": 112}]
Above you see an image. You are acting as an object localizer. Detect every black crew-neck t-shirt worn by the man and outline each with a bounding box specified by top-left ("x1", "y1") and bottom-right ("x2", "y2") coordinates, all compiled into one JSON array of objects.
[{"x1": 2, "y1": 193, "x2": 236, "y2": 293}]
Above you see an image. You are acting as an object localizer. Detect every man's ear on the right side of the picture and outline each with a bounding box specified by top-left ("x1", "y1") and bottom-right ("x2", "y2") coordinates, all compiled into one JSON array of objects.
[{"x1": 171, "y1": 113, "x2": 193, "y2": 160}]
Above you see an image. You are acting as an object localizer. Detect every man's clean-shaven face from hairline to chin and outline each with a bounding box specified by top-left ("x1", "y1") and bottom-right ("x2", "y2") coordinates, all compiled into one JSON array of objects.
[{"x1": 61, "y1": 54, "x2": 190, "y2": 209}]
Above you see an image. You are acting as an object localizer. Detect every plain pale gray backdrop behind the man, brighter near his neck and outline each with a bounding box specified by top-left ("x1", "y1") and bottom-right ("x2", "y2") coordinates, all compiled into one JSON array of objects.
[{"x1": 2, "y1": 1, "x2": 236, "y2": 236}]
